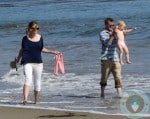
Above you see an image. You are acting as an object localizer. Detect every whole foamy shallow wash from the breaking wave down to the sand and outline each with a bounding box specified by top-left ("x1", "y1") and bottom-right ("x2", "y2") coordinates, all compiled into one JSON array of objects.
[{"x1": 0, "y1": 68, "x2": 150, "y2": 114}]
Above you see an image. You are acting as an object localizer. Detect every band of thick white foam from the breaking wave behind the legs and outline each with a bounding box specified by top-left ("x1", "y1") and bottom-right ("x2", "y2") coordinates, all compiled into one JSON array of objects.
[{"x1": 1, "y1": 67, "x2": 150, "y2": 94}]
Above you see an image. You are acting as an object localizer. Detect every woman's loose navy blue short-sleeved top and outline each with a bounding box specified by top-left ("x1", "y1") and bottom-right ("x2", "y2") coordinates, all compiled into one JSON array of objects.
[{"x1": 21, "y1": 36, "x2": 43, "y2": 64}]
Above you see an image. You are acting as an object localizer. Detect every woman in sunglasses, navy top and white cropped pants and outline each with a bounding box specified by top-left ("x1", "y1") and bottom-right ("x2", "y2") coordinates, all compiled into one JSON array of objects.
[{"x1": 16, "y1": 21, "x2": 59, "y2": 105}]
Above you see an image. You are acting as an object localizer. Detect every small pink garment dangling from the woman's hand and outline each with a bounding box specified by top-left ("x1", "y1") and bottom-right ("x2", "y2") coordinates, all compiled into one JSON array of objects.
[{"x1": 54, "y1": 53, "x2": 65, "y2": 76}]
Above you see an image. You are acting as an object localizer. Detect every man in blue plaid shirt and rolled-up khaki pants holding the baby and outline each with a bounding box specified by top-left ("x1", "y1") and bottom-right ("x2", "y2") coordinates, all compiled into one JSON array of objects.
[{"x1": 100, "y1": 18, "x2": 122, "y2": 98}]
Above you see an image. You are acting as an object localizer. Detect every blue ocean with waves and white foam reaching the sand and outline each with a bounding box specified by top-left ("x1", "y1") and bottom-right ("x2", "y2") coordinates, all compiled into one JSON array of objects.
[{"x1": 0, "y1": 0, "x2": 150, "y2": 114}]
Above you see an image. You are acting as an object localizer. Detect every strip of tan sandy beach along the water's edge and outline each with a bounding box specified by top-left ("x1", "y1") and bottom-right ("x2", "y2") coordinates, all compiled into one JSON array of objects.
[{"x1": 0, "y1": 106, "x2": 150, "y2": 119}]
